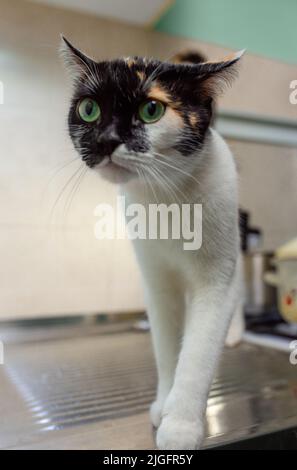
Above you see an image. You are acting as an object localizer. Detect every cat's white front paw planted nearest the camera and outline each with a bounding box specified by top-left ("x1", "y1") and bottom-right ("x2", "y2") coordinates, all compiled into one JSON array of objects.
[{"x1": 157, "y1": 416, "x2": 204, "y2": 450}]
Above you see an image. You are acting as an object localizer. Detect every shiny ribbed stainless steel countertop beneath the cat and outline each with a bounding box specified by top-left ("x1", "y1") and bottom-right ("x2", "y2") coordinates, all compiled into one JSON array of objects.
[{"x1": 0, "y1": 321, "x2": 297, "y2": 449}]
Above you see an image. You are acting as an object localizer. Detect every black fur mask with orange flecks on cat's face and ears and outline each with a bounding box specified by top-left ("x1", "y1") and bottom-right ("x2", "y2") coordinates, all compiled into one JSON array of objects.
[{"x1": 65, "y1": 40, "x2": 238, "y2": 167}]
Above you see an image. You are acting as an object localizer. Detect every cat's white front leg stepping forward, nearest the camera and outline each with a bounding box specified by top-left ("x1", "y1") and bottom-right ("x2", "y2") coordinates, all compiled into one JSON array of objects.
[{"x1": 157, "y1": 262, "x2": 238, "y2": 450}]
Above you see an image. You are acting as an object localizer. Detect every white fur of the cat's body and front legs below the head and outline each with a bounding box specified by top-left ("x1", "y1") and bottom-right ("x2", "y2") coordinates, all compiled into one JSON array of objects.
[{"x1": 118, "y1": 130, "x2": 242, "y2": 450}]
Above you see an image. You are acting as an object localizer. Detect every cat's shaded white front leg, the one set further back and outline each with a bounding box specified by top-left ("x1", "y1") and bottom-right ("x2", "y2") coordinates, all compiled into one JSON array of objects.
[{"x1": 145, "y1": 271, "x2": 184, "y2": 428}]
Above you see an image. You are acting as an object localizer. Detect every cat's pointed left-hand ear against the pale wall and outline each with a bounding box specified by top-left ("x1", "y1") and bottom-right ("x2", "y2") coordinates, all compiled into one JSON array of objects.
[{"x1": 60, "y1": 35, "x2": 96, "y2": 79}]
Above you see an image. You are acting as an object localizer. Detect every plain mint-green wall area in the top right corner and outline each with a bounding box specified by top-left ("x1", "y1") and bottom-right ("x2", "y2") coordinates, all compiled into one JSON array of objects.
[{"x1": 155, "y1": 0, "x2": 297, "y2": 63}]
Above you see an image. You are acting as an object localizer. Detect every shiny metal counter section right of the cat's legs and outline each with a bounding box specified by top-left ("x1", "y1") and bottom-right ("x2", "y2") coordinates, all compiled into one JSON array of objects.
[{"x1": 207, "y1": 344, "x2": 297, "y2": 445}]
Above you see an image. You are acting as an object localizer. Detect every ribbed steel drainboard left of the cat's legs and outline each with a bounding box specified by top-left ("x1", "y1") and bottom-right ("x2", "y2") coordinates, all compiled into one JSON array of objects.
[{"x1": 6, "y1": 326, "x2": 155, "y2": 431}]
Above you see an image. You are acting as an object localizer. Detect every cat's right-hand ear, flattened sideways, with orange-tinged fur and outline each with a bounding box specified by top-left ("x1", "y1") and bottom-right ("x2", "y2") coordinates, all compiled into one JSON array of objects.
[{"x1": 194, "y1": 50, "x2": 245, "y2": 97}]
